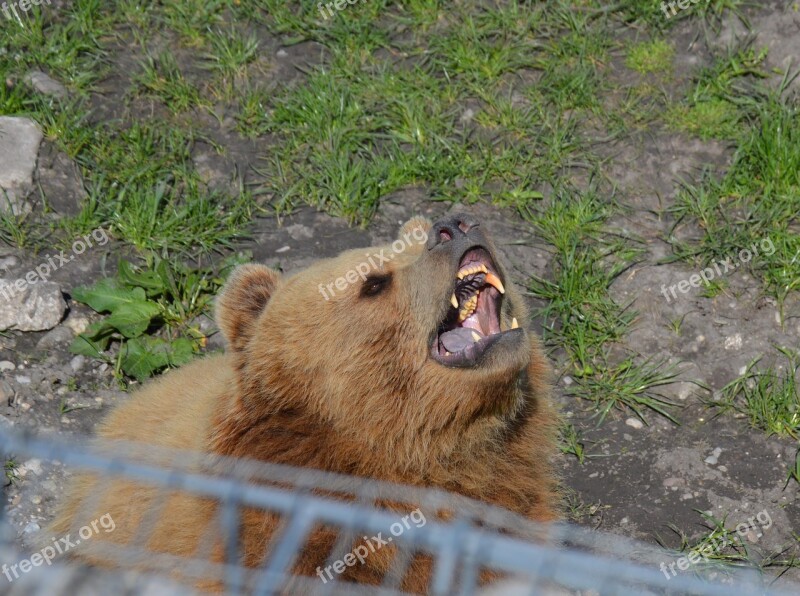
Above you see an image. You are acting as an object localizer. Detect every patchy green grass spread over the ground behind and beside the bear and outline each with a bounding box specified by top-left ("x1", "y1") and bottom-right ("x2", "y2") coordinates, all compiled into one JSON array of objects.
[{"x1": 0, "y1": 0, "x2": 784, "y2": 434}]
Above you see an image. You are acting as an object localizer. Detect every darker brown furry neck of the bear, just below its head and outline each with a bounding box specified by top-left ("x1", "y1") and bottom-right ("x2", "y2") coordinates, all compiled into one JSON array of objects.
[{"x1": 211, "y1": 370, "x2": 537, "y2": 498}]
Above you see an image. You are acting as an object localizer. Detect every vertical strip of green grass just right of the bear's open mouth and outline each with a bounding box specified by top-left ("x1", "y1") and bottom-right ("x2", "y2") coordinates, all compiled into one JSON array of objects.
[{"x1": 529, "y1": 186, "x2": 677, "y2": 423}]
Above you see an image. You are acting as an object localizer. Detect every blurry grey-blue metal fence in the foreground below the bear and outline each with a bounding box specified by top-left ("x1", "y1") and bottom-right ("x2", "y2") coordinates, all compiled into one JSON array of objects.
[{"x1": 0, "y1": 430, "x2": 800, "y2": 596}]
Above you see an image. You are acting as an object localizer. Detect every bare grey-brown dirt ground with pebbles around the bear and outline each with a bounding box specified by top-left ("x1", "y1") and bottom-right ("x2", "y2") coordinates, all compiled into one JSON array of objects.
[{"x1": 0, "y1": 2, "x2": 800, "y2": 592}]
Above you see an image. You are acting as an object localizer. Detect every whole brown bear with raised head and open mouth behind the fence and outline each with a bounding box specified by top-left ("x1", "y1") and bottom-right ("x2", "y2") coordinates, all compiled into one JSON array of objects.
[{"x1": 51, "y1": 215, "x2": 557, "y2": 593}]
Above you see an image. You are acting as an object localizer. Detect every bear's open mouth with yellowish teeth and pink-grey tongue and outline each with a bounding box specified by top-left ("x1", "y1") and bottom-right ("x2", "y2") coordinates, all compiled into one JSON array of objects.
[{"x1": 431, "y1": 247, "x2": 519, "y2": 366}]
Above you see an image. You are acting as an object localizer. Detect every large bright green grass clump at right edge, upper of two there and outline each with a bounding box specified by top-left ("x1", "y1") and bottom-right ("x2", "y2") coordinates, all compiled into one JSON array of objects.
[{"x1": 671, "y1": 82, "x2": 800, "y2": 310}]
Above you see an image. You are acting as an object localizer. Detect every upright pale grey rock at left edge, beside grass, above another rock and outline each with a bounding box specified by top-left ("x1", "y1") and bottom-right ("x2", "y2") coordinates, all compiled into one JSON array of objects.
[{"x1": 0, "y1": 116, "x2": 42, "y2": 214}]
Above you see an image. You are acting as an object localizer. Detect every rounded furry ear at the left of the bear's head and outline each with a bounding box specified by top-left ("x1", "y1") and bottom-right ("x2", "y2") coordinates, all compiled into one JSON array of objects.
[{"x1": 216, "y1": 265, "x2": 281, "y2": 351}]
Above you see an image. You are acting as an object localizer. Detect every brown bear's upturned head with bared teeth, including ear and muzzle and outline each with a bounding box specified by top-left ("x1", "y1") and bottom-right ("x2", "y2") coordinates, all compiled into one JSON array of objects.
[{"x1": 217, "y1": 214, "x2": 547, "y2": 467}]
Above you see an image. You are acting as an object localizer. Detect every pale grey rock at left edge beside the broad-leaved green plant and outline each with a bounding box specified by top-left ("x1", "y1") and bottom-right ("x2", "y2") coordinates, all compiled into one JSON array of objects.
[{"x1": 0, "y1": 280, "x2": 67, "y2": 331}]
